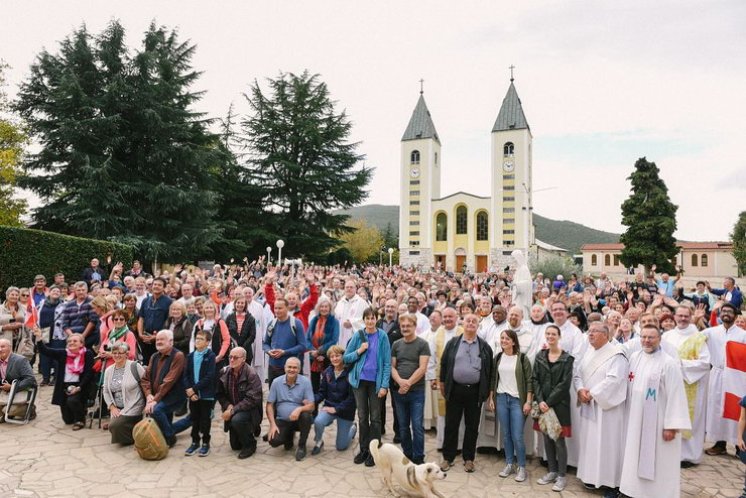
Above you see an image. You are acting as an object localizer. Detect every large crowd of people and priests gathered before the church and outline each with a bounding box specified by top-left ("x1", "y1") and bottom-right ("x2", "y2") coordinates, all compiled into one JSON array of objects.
[{"x1": 0, "y1": 258, "x2": 746, "y2": 497}]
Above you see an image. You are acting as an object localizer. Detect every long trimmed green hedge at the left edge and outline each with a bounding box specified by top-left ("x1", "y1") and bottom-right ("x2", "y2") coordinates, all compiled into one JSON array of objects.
[{"x1": 0, "y1": 226, "x2": 134, "y2": 292}]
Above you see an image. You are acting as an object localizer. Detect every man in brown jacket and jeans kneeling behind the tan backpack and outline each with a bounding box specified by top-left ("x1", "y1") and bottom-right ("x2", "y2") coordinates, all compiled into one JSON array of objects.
[{"x1": 140, "y1": 330, "x2": 186, "y2": 447}]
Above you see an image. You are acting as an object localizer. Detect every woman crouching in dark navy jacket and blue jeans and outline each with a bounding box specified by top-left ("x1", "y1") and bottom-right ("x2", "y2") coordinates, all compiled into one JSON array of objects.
[{"x1": 311, "y1": 344, "x2": 357, "y2": 455}]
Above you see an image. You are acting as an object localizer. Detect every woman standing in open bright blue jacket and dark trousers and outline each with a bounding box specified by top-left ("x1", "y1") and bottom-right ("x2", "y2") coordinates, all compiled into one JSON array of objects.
[{"x1": 344, "y1": 308, "x2": 391, "y2": 467}]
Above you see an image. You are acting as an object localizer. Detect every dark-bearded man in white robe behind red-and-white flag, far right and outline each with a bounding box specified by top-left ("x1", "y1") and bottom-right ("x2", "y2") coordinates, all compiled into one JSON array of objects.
[{"x1": 702, "y1": 303, "x2": 746, "y2": 455}]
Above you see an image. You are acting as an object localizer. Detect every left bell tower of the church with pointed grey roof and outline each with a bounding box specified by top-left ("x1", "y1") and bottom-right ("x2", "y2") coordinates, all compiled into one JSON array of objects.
[{"x1": 399, "y1": 80, "x2": 441, "y2": 268}]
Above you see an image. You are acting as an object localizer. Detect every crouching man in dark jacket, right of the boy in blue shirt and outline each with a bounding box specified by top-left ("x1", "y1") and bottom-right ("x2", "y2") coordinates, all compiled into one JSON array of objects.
[{"x1": 214, "y1": 341, "x2": 262, "y2": 460}]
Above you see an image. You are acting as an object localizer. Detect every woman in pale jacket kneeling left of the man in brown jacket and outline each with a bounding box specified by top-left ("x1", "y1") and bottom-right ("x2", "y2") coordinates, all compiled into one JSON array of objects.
[{"x1": 103, "y1": 342, "x2": 145, "y2": 446}]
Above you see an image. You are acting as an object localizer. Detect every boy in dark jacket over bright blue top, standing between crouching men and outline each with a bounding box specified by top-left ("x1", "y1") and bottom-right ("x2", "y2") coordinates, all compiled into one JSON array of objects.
[{"x1": 184, "y1": 330, "x2": 217, "y2": 457}]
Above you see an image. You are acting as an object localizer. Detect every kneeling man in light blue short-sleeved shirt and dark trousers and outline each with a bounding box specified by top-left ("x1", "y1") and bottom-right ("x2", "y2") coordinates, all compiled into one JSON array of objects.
[{"x1": 266, "y1": 356, "x2": 315, "y2": 461}]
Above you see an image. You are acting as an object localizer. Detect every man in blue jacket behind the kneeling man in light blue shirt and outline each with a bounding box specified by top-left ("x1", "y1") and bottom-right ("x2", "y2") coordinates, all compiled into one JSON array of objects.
[{"x1": 262, "y1": 298, "x2": 306, "y2": 388}]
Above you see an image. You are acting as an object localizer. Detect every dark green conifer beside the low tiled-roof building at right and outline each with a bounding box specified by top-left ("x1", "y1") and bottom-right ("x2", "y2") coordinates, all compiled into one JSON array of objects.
[{"x1": 620, "y1": 157, "x2": 679, "y2": 273}]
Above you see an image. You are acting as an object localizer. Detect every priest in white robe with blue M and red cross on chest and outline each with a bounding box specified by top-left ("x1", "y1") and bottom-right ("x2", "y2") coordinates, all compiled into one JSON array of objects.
[{"x1": 619, "y1": 325, "x2": 692, "y2": 498}]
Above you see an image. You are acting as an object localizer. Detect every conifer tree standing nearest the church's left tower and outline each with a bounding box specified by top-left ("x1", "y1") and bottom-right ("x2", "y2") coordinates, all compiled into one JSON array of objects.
[{"x1": 242, "y1": 72, "x2": 372, "y2": 256}]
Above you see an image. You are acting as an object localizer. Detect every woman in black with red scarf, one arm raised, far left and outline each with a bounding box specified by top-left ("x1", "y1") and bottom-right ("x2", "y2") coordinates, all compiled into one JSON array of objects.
[{"x1": 35, "y1": 329, "x2": 93, "y2": 431}]
